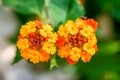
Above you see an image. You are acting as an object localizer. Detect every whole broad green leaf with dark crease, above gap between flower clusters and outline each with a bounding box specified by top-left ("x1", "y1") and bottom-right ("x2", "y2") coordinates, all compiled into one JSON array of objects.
[{"x1": 48, "y1": 0, "x2": 85, "y2": 25}]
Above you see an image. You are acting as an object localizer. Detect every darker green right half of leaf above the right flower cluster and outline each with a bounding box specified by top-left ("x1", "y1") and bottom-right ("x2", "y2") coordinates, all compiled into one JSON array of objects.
[{"x1": 67, "y1": 1, "x2": 85, "y2": 20}]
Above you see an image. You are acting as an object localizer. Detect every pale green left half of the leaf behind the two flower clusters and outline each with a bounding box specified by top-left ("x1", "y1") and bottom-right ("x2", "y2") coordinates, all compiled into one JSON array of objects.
[{"x1": 48, "y1": 0, "x2": 70, "y2": 24}]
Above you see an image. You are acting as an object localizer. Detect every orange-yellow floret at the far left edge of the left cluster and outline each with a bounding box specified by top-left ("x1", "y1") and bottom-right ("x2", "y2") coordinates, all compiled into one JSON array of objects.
[{"x1": 17, "y1": 38, "x2": 29, "y2": 50}]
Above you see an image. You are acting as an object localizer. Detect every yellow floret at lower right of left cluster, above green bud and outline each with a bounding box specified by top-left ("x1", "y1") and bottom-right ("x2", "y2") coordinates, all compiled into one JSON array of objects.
[{"x1": 42, "y1": 42, "x2": 56, "y2": 55}]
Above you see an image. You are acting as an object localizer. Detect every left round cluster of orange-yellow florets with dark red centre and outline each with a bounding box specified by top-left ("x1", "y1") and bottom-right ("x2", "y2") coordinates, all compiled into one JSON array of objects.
[{"x1": 17, "y1": 21, "x2": 58, "y2": 63}]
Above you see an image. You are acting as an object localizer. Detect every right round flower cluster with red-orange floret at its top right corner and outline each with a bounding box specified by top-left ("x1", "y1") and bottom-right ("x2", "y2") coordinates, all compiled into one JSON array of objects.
[{"x1": 56, "y1": 18, "x2": 98, "y2": 65}]
